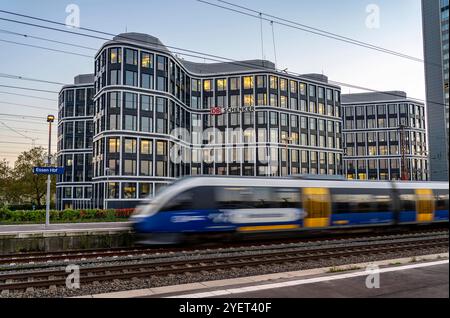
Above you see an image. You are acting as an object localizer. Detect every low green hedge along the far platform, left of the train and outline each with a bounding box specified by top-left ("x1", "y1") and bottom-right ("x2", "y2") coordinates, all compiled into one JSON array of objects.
[{"x1": 0, "y1": 208, "x2": 134, "y2": 223}]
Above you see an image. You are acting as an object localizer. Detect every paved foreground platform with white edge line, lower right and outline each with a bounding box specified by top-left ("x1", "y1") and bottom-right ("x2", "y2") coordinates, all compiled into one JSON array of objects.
[{"x1": 81, "y1": 253, "x2": 449, "y2": 299}]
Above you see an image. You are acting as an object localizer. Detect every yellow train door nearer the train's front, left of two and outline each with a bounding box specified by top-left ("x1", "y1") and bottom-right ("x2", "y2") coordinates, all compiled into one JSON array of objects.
[{"x1": 302, "y1": 188, "x2": 331, "y2": 228}]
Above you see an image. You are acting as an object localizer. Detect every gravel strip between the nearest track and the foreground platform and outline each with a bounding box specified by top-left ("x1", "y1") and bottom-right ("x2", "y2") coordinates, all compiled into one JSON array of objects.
[{"x1": 0, "y1": 247, "x2": 448, "y2": 298}]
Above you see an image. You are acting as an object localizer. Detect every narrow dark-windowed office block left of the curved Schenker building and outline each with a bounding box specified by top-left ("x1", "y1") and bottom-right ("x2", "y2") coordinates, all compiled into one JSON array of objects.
[{"x1": 56, "y1": 74, "x2": 94, "y2": 209}]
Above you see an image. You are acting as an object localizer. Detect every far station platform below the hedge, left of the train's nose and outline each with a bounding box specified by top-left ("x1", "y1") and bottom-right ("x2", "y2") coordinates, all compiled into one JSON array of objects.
[{"x1": 0, "y1": 222, "x2": 133, "y2": 255}]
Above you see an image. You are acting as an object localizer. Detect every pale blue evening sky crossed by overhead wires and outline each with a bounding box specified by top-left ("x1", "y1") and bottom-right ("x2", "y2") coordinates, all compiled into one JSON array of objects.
[{"x1": 0, "y1": 0, "x2": 425, "y2": 164}]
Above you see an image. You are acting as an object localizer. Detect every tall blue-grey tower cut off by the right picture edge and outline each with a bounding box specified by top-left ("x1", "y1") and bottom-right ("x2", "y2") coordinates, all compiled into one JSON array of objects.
[{"x1": 422, "y1": 0, "x2": 449, "y2": 181}]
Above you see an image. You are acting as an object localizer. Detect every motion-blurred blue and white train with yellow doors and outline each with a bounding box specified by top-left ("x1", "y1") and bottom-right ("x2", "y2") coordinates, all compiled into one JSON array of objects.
[{"x1": 131, "y1": 177, "x2": 449, "y2": 244}]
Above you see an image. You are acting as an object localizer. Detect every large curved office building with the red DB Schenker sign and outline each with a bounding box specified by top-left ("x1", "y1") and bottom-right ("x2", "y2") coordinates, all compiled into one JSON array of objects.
[{"x1": 88, "y1": 33, "x2": 343, "y2": 208}]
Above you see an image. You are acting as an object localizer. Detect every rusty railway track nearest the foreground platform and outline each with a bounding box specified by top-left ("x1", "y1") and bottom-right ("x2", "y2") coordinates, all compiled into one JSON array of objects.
[{"x1": 0, "y1": 236, "x2": 449, "y2": 292}]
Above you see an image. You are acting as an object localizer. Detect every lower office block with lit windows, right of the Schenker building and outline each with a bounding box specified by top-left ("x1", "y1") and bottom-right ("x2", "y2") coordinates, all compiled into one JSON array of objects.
[{"x1": 342, "y1": 91, "x2": 429, "y2": 180}]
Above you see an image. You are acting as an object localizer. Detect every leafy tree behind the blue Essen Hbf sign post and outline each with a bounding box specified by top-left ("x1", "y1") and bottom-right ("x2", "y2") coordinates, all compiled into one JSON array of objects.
[{"x1": 12, "y1": 147, "x2": 56, "y2": 208}]
